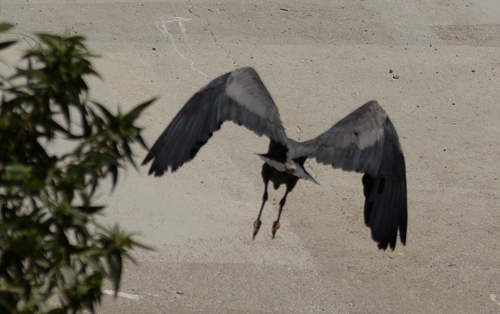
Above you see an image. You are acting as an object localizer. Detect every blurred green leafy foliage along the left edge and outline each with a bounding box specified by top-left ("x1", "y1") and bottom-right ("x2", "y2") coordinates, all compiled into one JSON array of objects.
[{"x1": 0, "y1": 24, "x2": 153, "y2": 313}]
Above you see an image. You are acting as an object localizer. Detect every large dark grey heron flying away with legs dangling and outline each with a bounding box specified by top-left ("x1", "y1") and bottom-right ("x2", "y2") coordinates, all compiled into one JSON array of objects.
[{"x1": 142, "y1": 67, "x2": 407, "y2": 250}]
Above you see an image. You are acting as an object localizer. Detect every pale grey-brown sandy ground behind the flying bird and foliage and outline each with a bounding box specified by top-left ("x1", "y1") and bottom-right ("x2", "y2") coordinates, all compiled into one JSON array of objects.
[{"x1": 0, "y1": 0, "x2": 500, "y2": 313}]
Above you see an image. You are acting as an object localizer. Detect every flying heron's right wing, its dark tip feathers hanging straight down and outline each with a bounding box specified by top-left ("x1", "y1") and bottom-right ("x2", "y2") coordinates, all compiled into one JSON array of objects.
[{"x1": 292, "y1": 101, "x2": 408, "y2": 250}]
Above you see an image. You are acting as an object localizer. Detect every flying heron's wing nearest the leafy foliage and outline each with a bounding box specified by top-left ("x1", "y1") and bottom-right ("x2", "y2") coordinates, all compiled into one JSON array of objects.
[{"x1": 142, "y1": 67, "x2": 287, "y2": 176}]
